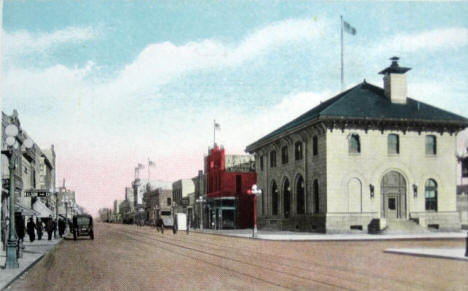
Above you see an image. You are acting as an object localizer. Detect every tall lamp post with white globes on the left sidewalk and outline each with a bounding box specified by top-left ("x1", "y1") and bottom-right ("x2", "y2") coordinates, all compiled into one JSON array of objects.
[{"x1": 5, "y1": 124, "x2": 33, "y2": 269}]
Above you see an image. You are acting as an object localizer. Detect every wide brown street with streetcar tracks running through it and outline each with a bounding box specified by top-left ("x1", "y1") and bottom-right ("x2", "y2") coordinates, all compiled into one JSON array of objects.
[{"x1": 10, "y1": 223, "x2": 468, "y2": 290}]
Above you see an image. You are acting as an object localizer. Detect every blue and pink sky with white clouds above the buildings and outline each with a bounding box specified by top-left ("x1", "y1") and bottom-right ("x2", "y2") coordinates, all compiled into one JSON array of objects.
[{"x1": 0, "y1": 0, "x2": 468, "y2": 214}]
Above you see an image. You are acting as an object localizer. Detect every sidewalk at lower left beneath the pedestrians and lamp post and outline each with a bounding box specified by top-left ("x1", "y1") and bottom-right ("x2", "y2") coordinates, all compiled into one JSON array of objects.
[{"x1": 0, "y1": 235, "x2": 62, "y2": 290}]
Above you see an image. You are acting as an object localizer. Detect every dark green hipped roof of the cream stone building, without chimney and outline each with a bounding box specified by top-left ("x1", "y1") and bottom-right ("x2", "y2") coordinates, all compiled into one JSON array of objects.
[{"x1": 247, "y1": 81, "x2": 468, "y2": 152}]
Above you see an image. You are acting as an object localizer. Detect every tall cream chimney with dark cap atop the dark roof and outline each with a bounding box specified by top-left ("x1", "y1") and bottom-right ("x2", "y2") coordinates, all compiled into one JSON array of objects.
[{"x1": 379, "y1": 57, "x2": 411, "y2": 104}]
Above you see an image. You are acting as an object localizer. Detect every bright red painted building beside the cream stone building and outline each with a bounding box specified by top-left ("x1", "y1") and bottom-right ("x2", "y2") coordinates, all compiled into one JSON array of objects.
[{"x1": 205, "y1": 145, "x2": 257, "y2": 229}]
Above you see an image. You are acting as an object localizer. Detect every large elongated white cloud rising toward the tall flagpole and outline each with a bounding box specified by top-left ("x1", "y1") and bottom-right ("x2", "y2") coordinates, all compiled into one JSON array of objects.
[{"x1": 110, "y1": 19, "x2": 327, "y2": 98}]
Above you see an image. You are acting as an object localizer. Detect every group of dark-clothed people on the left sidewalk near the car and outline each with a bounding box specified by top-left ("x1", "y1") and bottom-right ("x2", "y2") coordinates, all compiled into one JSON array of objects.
[{"x1": 16, "y1": 216, "x2": 72, "y2": 242}]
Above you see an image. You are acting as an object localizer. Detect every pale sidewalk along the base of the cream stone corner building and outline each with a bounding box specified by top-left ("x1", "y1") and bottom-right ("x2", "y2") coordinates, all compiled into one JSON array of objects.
[{"x1": 191, "y1": 229, "x2": 467, "y2": 241}]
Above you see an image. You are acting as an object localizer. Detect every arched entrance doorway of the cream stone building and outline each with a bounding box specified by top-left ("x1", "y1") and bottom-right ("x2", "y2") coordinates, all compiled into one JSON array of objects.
[{"x1": 381, "y1": 171, "x2": 406, "y2": 220}]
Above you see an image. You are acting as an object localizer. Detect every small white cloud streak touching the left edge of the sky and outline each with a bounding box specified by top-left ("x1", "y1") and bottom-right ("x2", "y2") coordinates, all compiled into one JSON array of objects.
[{"x1": 2, "y1": 27, "x2": 97, "y2": 57}]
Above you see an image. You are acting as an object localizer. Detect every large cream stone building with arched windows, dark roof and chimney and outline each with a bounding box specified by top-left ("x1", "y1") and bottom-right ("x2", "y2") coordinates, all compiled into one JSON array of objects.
[{"x1": 246, "y1": 58, "x2": 468, "y2": 233}]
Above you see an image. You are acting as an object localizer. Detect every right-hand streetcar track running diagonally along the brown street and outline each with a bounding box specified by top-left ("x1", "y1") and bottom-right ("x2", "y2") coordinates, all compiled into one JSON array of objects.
[{"x1": 124, "y1": 230, "x2": 438, "y2": 290}]
